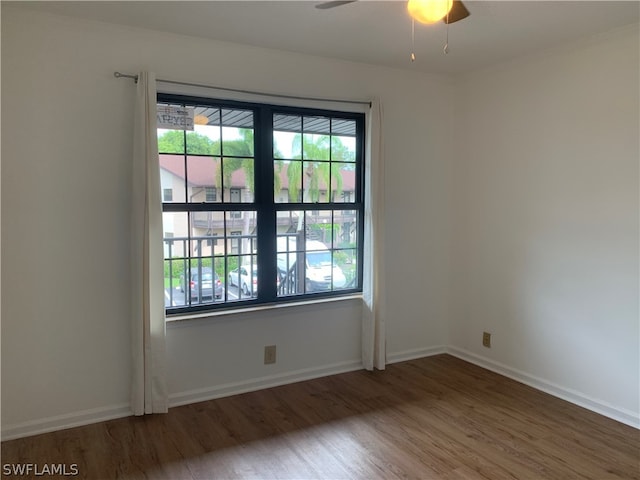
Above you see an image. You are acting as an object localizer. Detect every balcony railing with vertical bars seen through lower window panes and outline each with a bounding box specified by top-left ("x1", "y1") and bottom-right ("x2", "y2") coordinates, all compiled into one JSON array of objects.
[{"x1": 164, "y1": 229, "x2": 358, "y2": 313}]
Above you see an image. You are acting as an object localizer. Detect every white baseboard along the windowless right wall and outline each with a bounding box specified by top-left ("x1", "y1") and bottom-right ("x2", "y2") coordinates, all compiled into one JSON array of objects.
[{"x1": 447, "y1": 346, "x2": 640, "y2": 429}]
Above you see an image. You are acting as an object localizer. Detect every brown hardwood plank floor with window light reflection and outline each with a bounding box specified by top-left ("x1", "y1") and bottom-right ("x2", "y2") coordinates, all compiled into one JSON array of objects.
[{"x1": 2, "y1": 355, "x2": 640, "y2": 480}]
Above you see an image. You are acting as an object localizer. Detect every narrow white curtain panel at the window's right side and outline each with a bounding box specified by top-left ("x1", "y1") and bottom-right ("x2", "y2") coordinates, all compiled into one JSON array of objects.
[{"x1": 362, "y1": 99, "x2": 386, "y2": 370}]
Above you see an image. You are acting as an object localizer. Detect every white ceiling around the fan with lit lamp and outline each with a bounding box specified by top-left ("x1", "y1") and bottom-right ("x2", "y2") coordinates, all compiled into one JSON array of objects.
[{"x1": 10, "y1": 0, "x2": 640, "y2": 74}]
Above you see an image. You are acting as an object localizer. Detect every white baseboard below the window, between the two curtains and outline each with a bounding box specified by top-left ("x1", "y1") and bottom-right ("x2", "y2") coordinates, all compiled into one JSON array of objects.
[{"x1": 169, "y1": 360, "x2": 362, "y2": 408}]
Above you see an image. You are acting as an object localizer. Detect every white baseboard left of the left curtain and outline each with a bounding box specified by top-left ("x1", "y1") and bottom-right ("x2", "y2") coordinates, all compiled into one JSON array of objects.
[{"x1": 1, "y1": 404, "x2": 133, "y2": 442}]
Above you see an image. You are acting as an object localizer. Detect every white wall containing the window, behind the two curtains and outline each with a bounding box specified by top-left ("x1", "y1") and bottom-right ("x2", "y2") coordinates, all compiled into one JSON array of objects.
[{"x1": 2, "y1": 5, "x2": 453, "y2": 438}]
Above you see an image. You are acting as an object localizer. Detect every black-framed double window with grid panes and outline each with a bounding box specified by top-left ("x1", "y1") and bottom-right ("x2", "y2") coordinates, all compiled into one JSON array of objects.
[{"x1": 158, "y1": 95, "x2": 364, "y2": 315}]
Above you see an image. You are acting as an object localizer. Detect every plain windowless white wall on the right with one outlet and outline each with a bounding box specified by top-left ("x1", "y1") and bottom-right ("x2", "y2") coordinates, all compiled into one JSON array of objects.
[{"x1": 450, "y1": 26, "x2": 640, "y2": 426}]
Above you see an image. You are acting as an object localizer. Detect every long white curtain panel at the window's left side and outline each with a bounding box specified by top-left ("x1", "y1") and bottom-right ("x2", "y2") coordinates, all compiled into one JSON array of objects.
[{"x1": 131, "y1": 72, "x2": 168, "y2": 415}]
